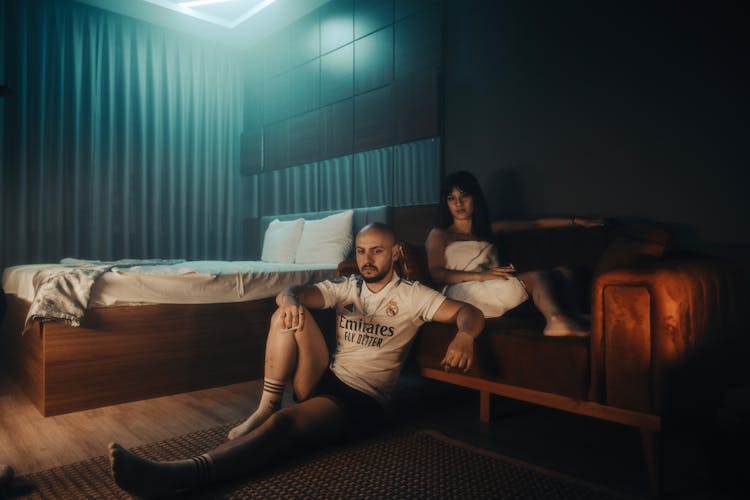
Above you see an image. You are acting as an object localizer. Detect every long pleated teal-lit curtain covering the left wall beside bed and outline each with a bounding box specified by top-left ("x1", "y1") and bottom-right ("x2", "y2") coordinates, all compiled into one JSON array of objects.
[{"x1": 0, "y1": 0, "x2": 243, "y2": 267}]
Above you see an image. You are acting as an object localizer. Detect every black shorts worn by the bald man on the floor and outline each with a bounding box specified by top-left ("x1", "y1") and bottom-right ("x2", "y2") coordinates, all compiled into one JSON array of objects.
[{"x1": 295, "y1": 368, "x2": 385, "y2": 430}]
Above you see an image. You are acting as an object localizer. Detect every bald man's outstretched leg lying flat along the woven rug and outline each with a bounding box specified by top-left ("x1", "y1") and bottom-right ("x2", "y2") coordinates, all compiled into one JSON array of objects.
[{"x1": 109, "y1": 397, "x2": 346, "y2": 497}]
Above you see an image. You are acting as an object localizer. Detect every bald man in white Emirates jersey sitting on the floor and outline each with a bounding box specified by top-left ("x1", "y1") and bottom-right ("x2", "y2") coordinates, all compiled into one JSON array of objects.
[{"x1": 109, "y1": 223, "x2": 484, "y2": 496}]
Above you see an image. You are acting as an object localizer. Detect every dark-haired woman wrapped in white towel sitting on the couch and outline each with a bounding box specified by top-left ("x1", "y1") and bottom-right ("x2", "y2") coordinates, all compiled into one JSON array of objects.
[{"x1": 425, "y1": 172, "x2": 602, "y2": 336}]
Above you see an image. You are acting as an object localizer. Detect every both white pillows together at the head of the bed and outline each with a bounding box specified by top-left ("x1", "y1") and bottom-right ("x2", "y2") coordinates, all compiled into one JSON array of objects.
[{"x1": 261, "y1": 210, "x2": 354, "y2": 265}]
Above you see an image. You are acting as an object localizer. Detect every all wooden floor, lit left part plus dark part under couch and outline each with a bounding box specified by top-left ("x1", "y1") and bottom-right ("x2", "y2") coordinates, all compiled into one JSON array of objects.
[{"x1": 0, "y1": 370, "x2": 735, "y2": 500}]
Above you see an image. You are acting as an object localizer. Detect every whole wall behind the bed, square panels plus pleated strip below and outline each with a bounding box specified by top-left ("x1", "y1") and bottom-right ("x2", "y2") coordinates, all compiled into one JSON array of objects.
[{"x1": 240, "y1": 0, "x2": 442, "y2": 258}]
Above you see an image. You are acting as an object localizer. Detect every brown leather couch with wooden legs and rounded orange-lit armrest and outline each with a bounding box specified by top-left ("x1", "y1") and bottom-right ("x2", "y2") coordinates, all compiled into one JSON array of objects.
[{"x1": 339, "y1": 222, "x2": 747, "y2": 491}]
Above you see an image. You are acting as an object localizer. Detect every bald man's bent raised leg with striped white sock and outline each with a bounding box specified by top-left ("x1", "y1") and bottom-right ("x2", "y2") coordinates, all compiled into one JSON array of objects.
[{"x1": 229, "y1": 309, "x2": 328, "y2": 439}]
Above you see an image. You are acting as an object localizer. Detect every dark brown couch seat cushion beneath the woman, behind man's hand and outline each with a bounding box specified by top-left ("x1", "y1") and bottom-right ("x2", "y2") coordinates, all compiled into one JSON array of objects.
[{"x1": 413, "y1": 315, "x2": 589, "y2": 399}]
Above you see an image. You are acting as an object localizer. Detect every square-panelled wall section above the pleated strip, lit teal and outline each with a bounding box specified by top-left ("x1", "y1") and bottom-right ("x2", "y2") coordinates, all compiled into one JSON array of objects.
[{"x1": 241, "y1": 0, "x2": 441, "y2": 175}]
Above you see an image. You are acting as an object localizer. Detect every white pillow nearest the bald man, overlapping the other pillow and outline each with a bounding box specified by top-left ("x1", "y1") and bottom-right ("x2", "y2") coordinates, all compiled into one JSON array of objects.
[{"x1": 294, "y1": 210, "x2": 354, "y2": 264}]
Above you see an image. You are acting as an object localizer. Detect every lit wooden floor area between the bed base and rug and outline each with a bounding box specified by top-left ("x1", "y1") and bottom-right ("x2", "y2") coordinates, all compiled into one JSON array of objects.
[{"x1": 0, "y1": 377, "x2": 292, "y2": 475}]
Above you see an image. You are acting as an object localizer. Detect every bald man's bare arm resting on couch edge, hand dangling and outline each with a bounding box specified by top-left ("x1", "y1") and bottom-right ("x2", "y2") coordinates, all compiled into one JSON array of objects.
[{"x1": 432, "y1": 299, "x2": 484, "y2": 372}]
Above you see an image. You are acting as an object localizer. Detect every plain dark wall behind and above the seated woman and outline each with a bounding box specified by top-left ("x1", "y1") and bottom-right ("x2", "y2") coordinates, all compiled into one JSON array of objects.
[{"x1": 444, "y1": 0, "x2": 750, "y2": 268}]
